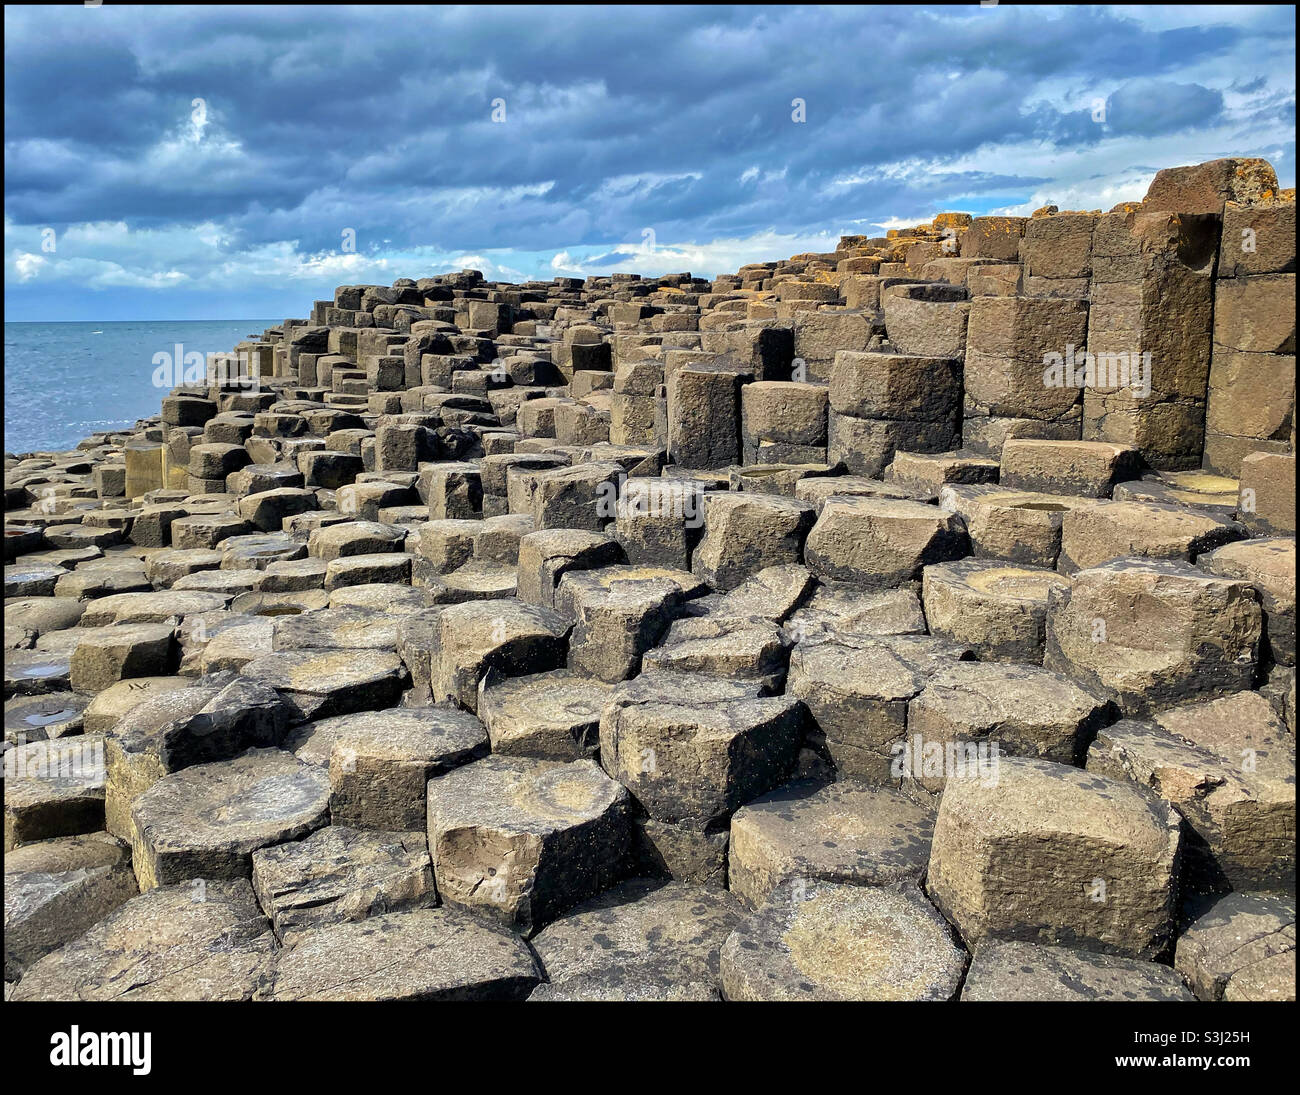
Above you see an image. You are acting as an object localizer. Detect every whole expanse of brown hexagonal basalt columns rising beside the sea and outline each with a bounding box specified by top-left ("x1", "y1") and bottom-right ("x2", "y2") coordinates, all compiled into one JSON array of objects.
[{"x1": 4, "y1": 160, "x2": 1296, "y2": 1000}]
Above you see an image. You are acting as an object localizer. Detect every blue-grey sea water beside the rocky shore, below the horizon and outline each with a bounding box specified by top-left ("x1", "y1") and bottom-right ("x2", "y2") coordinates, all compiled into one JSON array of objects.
[{"x1": 4, "y1": 320, "x2": 280, "y2": 453}]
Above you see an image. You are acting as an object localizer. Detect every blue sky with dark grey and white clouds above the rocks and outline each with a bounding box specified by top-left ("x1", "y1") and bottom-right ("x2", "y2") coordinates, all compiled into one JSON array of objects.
[{"x1": 4, "y1": 4, "x2": 1296, "y2": 321}]
